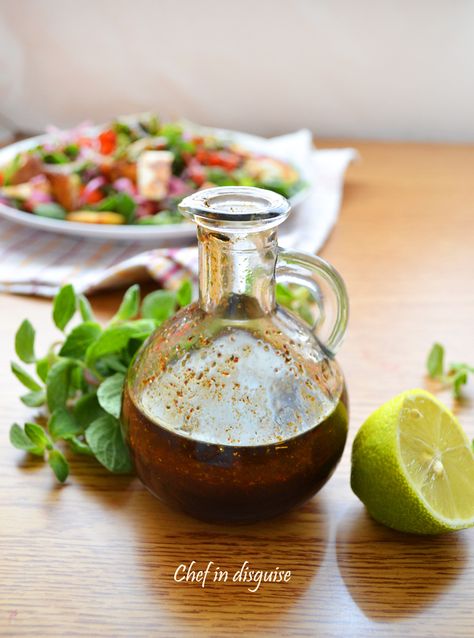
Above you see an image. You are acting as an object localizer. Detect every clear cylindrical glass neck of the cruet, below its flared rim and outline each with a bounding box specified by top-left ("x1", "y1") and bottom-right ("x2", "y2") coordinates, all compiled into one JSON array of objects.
[{"x1": 198, "y1": 226, "x2": 278, "y2": 319}]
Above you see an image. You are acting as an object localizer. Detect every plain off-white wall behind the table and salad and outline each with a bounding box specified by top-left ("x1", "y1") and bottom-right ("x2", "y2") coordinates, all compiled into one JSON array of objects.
[{"x1": 0, "y1": 0, "x2": 474, "y2": 142}]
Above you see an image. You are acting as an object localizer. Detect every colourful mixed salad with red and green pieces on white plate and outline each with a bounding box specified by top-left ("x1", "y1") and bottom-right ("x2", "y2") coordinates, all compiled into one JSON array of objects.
[{"x1": 0, "y1": 113, "x2": 306, "y2": 225}]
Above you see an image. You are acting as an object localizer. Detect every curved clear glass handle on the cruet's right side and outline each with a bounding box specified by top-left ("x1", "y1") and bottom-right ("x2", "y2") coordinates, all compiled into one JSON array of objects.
[{"x1": 275, "y1": 249, "x2": 349, "y2": 355}]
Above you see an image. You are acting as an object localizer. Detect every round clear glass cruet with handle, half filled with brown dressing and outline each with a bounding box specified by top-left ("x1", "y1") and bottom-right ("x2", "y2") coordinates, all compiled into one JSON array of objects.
[{"x1": 122, "y1": 187, "x2": 348, "y2": 523}]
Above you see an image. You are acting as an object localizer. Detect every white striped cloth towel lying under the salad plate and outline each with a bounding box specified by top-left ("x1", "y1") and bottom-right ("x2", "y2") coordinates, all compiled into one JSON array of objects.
[{"x1": 0, "y1": 148, "x2": 356, "y2": 297}]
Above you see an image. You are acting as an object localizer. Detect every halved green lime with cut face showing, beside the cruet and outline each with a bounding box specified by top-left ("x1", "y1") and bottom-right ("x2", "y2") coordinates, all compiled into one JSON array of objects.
[{"x1": 351, "y1": 390, "x2": 474, "y2": 534}]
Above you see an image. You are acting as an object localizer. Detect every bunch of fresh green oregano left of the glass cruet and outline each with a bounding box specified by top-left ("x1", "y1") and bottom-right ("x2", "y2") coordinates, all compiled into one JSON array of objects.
[{"x1": 10, "y1": 280, "x2": 192, "y2": 482}]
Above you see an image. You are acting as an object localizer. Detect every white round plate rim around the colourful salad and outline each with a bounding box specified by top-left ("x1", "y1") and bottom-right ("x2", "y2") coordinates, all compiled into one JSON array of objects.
[{"x1": 0, "y1": 122, "x2": 311, "y2": 242}]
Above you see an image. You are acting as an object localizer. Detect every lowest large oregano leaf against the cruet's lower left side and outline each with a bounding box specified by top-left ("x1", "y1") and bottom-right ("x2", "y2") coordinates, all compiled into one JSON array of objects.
[{"x1": 86, "y1": 414, "x2": 132, "y2": 474}]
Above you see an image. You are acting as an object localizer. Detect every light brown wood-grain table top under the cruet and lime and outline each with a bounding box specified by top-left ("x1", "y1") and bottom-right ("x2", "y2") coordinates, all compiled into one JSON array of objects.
[{"x1": 0, "y1": 141, "x2": 474, "y2": 638}]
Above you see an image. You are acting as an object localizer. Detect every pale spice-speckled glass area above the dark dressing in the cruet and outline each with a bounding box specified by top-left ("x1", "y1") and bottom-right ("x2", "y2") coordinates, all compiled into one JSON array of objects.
[{"x1": 139, "y1": 331, "x2": 335, "y2": 446}]
